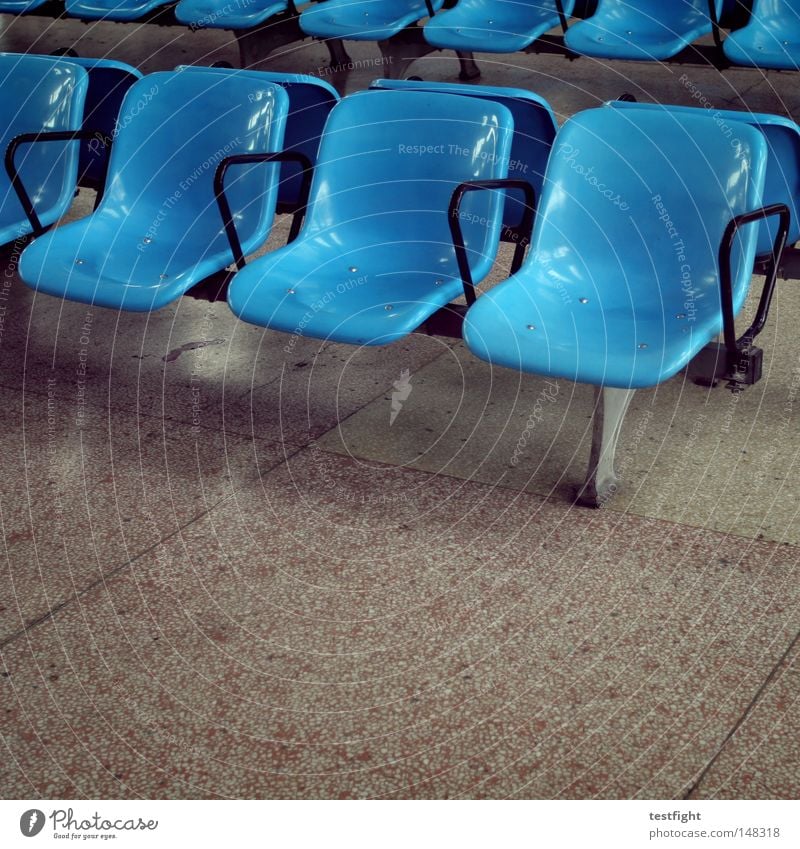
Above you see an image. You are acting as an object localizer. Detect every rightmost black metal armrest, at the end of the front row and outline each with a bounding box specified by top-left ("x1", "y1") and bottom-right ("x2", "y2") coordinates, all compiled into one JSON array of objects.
[{"x1": 719, "y1": 203, "x2": 791, "y2": 382}]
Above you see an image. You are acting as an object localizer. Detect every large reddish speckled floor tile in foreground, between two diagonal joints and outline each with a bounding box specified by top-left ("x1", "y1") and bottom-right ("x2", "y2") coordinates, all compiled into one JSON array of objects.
[{"x1": 3, "y1": 452, "x2": 800, "y2": 798}]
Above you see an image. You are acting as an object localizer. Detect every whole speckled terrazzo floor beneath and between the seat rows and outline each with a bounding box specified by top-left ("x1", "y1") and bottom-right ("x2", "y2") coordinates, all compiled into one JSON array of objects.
[{"x1": 0, "y1": 17, "x2": 800, "y2": 798}]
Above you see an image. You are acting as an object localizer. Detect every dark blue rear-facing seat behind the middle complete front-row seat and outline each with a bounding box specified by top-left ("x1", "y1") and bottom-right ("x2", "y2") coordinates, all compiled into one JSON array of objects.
[{"x1": 370, "y1": 80, "x2": 558, "y2": 227}]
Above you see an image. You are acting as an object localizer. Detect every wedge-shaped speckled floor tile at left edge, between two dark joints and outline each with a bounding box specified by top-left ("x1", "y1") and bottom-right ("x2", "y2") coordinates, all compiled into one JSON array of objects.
[{"x1": 0, "y1": 382, "x2": 294, "y2": 641}]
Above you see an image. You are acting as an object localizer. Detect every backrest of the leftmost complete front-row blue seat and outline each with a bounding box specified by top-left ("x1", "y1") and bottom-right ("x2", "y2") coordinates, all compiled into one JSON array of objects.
[{"x1": 100, "y1": 72, "x2": 289, "y2": 248}]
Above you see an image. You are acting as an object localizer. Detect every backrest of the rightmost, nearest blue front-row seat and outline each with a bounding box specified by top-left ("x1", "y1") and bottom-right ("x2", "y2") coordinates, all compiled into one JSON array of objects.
[{"x1": 520, "y1": 108, "x2": 767, "y2": 322}]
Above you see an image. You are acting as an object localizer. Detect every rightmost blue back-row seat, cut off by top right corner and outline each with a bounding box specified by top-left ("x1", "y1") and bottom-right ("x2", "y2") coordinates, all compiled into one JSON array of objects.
[{"x1": 722, "y1": 0, "x2": 800, "y2": 71}]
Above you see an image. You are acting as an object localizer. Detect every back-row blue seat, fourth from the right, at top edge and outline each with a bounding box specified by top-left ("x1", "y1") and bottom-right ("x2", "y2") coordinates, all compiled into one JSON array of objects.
[{"x1": 300, "y1": 0, "x2": 444, "y2": 41}]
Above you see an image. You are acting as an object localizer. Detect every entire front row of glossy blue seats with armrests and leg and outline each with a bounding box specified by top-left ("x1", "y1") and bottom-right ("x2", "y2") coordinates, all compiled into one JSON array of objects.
[{"x1": 0, "y1": 54, "x2": 800, "y2": 504}]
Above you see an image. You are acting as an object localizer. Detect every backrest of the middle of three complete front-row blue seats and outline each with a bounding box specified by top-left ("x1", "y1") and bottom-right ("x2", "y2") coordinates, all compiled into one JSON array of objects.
[{"x1": 303, "y1": 91, "x2": 513, "y2": 268}]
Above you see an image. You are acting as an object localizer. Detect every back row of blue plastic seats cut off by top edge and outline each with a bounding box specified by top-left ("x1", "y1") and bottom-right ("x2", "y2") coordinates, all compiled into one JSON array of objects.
[{"x1": 0, "y1": 0, "x2": 800, "y2": 70}]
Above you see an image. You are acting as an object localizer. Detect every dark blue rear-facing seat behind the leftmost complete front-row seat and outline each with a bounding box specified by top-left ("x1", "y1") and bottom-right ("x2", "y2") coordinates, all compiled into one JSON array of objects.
[{"x1": 177, "y1": 65, "x2": 340, "y2": 212}]
